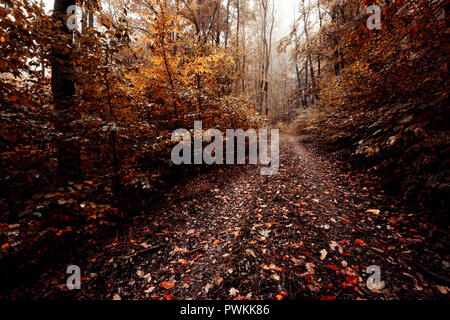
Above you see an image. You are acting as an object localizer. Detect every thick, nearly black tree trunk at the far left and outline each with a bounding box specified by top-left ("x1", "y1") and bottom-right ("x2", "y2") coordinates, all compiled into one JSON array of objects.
[{"x1": 52, "y1": 0, "x2": 81, "y2": 181}]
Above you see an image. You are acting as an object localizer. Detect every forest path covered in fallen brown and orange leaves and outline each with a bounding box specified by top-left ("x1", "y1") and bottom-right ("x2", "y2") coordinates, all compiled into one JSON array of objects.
[{"x1": 4, "y1": 136, "x2": 450, "y2": 300}]
